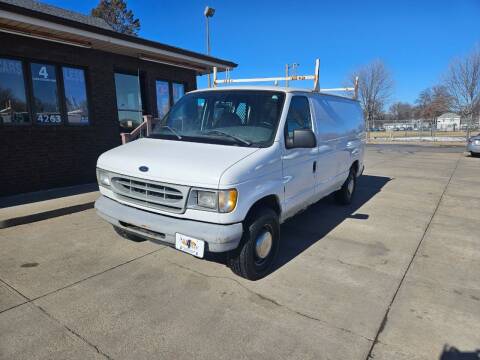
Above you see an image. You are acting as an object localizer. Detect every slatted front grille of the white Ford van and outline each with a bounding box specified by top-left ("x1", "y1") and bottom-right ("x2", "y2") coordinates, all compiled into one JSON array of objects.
[{"x1": 111, "y1": 175, "x2": 189, "y2": 213}]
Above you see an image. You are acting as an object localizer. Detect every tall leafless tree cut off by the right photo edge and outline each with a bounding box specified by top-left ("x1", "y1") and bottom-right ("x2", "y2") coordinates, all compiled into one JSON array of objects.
[{"x1": 444, "y1": 47, "x2": 480, "y2": 139}]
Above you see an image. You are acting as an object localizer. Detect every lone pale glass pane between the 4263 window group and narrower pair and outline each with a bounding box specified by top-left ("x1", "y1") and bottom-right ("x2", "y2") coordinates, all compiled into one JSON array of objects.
[{"x1": 115, "y1": 73, "x2": 143, "y2": 128}]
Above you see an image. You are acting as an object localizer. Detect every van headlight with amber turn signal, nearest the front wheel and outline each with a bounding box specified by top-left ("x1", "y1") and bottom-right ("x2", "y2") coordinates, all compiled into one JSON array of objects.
[{"x1": 188, "y1": 189, "x2": 237, "y2": 213}]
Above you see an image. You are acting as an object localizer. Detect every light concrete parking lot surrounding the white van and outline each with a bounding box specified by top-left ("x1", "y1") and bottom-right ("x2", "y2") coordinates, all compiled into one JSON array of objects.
[{"x1": 0, "y1": 145, "x2": 480, "y2": 360}]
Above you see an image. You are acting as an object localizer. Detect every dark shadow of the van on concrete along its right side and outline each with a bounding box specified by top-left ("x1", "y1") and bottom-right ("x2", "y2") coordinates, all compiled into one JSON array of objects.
[{"x1": 272, "y1": 175, "x2": 391, "y2": 272}]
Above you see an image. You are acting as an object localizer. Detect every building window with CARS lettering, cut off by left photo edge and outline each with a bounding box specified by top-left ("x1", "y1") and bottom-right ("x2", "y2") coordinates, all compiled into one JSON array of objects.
[{"x1": 0, "y1": 58, "x2": 30, "y2": 124}]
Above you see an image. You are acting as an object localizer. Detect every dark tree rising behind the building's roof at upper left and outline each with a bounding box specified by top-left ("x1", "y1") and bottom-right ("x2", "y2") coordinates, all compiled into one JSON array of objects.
[{"x1": 92, "y1": 0, "x2": 140, "y2": 36}]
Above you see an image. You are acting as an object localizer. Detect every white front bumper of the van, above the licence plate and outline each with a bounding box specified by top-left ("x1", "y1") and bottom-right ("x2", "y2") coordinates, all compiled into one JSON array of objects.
[{"x1": 95, "y1": 195, "x2": 243, "y2": 252}]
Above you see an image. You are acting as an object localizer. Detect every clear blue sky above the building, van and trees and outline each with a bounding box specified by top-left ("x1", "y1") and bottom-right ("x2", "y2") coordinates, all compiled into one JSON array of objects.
[{"x1": 43, "y1": 0, "x2": 480, "y2": 103}]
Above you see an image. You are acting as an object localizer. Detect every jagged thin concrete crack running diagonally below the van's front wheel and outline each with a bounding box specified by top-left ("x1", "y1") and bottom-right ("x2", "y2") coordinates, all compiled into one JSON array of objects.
[{"x1": 166, "y1": 260, "x2": 373, "y2": 342}]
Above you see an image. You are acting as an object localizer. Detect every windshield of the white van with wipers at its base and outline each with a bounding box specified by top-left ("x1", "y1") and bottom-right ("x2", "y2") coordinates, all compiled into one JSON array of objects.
[{"x1": 151, "y1": 90, "x2": 285, "y2": 147}]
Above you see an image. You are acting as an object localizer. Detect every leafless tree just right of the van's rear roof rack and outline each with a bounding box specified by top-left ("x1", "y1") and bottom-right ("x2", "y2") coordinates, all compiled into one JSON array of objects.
[{"x1": 350, "y1": 60, "x2": 393, "y2": 128}]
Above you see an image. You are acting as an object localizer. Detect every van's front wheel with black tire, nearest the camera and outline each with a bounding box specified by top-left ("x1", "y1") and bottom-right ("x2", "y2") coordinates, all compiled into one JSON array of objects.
[{"x1": 228, "y1": 209, "x2": 280, "y2": 280}]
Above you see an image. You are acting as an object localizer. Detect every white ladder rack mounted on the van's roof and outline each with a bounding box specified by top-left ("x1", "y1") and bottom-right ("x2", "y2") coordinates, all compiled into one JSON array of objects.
[{"x1": 213, "y1": 59, "x2": 358, "y2": 99}]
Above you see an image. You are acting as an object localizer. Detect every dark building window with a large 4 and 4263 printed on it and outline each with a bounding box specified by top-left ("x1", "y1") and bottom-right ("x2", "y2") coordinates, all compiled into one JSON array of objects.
[{"x1": 30, "y1": 63, "x2": 62, "y2": 125}]
